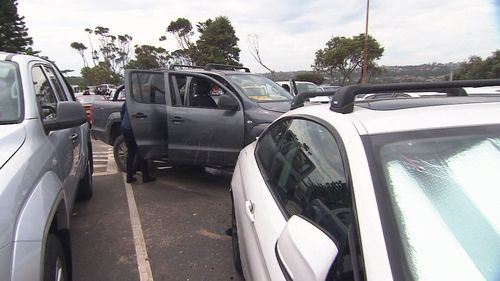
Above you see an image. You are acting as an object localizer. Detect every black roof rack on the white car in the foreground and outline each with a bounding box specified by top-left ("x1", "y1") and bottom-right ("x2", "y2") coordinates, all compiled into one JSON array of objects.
[{"x1": 290, "y1": 79, "x2": 500, "y2": 111}]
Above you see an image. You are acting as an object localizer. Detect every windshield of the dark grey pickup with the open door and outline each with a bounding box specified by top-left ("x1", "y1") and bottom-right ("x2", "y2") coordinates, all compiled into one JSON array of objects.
[{"x1": 228, "y1": 74, "x2": 293, "y2": 102}]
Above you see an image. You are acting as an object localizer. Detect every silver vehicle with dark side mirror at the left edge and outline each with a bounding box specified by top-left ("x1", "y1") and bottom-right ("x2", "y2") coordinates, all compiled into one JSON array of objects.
[{"x1": 0, "y1": 52, "x2": 92, "y2": 280}]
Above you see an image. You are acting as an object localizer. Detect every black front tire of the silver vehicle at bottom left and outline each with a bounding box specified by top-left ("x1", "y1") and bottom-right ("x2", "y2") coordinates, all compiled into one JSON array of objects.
[{"x1": 43, "y1": 233, "x2": 70, "y2": 281}]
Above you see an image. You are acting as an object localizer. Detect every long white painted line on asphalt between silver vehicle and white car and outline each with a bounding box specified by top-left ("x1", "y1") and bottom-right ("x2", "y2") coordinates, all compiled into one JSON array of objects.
[{"x1": 122, "y1": 173, "x2": 153, "y2": 281}]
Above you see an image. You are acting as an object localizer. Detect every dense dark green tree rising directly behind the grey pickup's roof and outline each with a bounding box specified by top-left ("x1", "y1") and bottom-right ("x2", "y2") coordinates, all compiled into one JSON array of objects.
[{"x1": 190, "y1": 17, "x2": 240, "y2": 65}]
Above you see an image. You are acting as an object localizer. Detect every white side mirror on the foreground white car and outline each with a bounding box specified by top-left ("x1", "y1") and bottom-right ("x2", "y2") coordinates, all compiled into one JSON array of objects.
[{"x1": 276, "y1": 216, "x2": 338, "y2": 281}]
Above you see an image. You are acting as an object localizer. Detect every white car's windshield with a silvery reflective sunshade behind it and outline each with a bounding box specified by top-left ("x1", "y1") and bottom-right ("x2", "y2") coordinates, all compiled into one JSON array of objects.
[{"x1": 376, "y1": 126, "x2": 500, "y2": 280}]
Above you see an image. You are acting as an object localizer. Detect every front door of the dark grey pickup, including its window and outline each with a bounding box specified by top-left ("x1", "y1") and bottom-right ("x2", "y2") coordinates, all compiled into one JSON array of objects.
[{"x1": 167, "y1": 71, "x2": 245, "y2": 166}]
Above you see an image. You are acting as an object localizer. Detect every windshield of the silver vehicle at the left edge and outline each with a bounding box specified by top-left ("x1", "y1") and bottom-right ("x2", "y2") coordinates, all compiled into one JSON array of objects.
[{"x1": 0, "y1": 61, "x2": 21, "y2": 124}]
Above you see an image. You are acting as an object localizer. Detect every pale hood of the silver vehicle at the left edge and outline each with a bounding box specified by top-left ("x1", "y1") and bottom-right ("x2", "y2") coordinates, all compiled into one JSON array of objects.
[{"x1": 0, "y1": 124, "x2": 26, "y2": 169}]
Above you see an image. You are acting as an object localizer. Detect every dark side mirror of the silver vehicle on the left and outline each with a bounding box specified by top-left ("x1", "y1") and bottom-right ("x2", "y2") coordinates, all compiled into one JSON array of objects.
[{"x1": 43, "y1": 101, "x2": 87, "y2": 132}]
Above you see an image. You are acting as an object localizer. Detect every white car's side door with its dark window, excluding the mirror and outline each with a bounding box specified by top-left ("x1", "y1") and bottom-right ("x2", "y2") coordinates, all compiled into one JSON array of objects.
[{"x1": 233, "y1": 115, "x2": 364, "y2": 280}]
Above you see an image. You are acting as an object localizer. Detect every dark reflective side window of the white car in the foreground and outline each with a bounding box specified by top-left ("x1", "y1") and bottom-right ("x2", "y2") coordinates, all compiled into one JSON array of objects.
[{"x1": 257, "y1": 119, "x2": 353, "y2": 280}]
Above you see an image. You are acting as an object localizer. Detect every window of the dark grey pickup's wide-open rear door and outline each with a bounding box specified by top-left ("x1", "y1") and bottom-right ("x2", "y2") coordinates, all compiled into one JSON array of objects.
[{"x1": 131, "y1": 72, "x2": 165, "y2": 104}]
